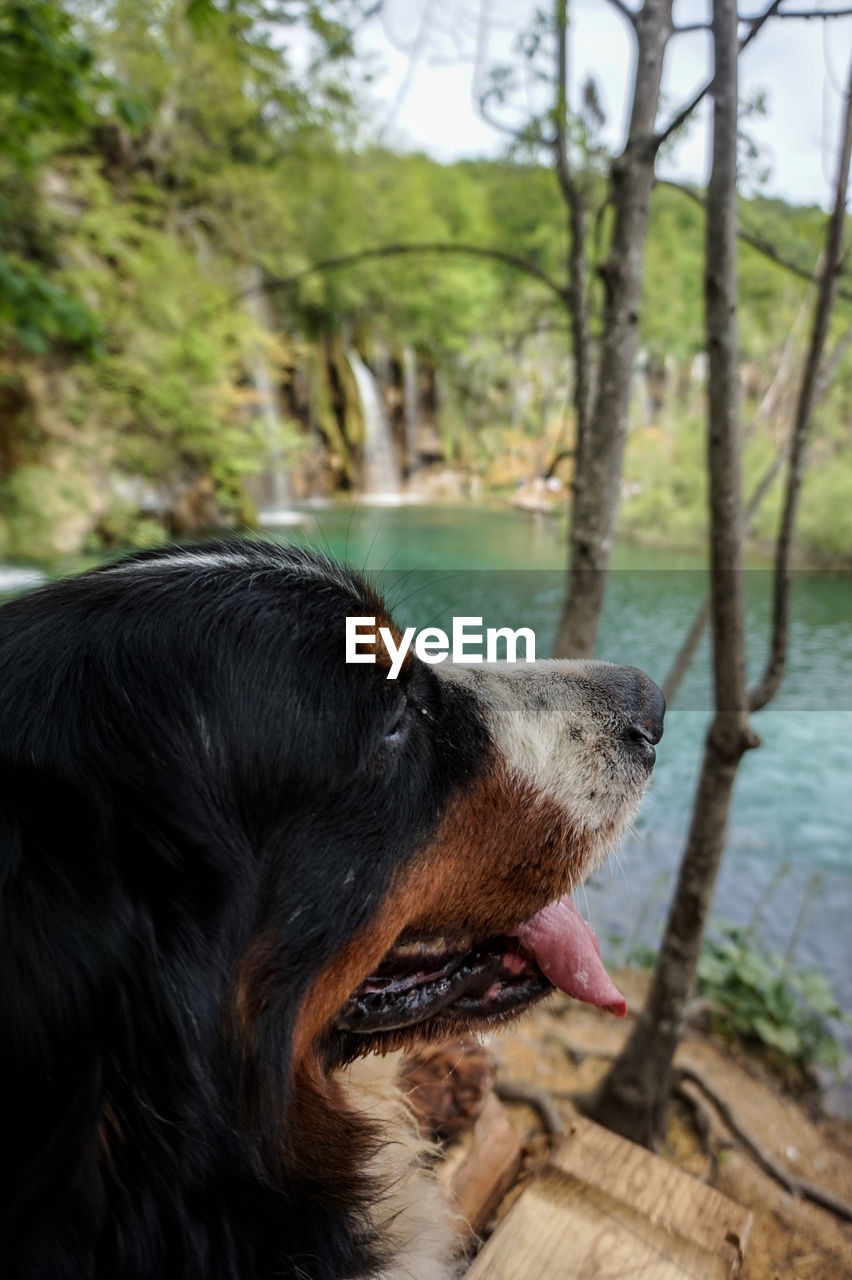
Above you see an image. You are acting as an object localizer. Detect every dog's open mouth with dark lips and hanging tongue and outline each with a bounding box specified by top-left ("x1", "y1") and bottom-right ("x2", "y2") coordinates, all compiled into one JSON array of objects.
[{"x1": 335, "y1": 896, "x2": 627, "y2": 1034}]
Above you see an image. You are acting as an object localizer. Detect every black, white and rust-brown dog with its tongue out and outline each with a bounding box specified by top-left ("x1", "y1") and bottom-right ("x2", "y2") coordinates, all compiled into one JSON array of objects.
[{"x1": 0, "y1": 540, "x2": 664, "y2": 1280}]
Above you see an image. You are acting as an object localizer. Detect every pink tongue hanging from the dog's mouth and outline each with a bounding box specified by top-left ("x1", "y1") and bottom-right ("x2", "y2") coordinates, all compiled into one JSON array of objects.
[{"x1": 506, "y1": 895, "x2": 627, "y2": 1018}]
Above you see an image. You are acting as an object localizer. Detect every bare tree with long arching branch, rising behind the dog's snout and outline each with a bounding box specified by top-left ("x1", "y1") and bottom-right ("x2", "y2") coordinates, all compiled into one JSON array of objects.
[{"x1": 245, "y1": 0, "x2": 844, "y2": 657}]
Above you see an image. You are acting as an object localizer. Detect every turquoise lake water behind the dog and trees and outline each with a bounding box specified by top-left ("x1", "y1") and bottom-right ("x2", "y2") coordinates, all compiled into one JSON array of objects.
[{"x1": 0, "y1": 504, "x2": 852, "y2": 1039}]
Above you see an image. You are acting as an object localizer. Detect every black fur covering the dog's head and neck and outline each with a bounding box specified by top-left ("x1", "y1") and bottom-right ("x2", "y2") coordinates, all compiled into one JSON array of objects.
[{"x1": 0, "y1": 541, "x2": 481, "y2": 1280}]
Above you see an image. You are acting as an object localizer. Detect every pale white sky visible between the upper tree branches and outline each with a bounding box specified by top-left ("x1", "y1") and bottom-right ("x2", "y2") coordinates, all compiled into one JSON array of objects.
[{"x1": 347, "y1": 0, "x2": 852, "y2": 207}]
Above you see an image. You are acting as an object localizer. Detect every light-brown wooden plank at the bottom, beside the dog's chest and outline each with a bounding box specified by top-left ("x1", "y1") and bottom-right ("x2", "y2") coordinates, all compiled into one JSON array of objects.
[{"x1": 466, "y1": 1120, "x2": 751, "y2": 1280}]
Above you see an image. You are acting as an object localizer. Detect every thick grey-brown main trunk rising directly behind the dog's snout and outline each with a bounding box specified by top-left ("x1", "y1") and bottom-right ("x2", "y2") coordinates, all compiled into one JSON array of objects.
[{"x1": 554, "y1": 0, "x2": 672, "y2": 658}]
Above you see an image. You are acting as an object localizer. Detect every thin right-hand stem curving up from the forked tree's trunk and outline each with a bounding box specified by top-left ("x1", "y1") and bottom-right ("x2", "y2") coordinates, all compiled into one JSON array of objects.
[{"x1": 748, "y1": 63, "x2": 852, "y2": 710}]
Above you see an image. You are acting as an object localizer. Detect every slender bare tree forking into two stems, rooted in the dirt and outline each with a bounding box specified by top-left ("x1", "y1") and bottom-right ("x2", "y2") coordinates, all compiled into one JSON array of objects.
[{"x1": 590, "y1": 37, "x2": 852, "y2": 1147}]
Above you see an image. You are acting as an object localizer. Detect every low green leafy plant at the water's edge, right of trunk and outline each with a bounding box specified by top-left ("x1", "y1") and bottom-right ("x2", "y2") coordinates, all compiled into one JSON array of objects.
[{"x1": 698, "y1": 925, "x2": 843, "y2": 1071}]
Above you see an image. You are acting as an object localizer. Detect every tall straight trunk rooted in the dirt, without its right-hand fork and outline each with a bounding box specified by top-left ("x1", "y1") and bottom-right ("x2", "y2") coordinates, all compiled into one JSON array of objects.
[{"x1": 580, "y1": 0, "x2": 757, "y2": 1147}]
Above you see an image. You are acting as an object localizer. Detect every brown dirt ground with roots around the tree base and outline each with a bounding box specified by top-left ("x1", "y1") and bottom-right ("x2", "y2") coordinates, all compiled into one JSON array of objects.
[{"x1": 490, "y1": 972, "x2": 852, "y2": 1280}]
